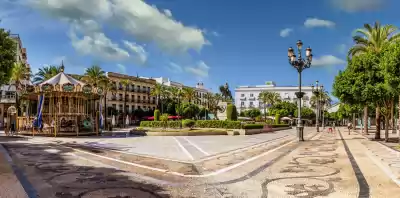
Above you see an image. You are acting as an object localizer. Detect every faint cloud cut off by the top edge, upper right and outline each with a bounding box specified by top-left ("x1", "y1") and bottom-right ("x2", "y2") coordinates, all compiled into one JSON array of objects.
[{"x1": 331, "y1": 0, "x2": 387, "y2": 12}]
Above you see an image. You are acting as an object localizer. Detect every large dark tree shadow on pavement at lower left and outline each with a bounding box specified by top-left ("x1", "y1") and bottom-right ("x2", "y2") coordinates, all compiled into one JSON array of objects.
[{"x1": 0, "y1": 137, "x2": 170, "y2": 198}]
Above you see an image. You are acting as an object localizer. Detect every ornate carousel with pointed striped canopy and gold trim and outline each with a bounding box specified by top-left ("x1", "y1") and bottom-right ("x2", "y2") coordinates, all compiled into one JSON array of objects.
[{"x1": 17, "y1": 65, "x2": 103, "y2": 137}]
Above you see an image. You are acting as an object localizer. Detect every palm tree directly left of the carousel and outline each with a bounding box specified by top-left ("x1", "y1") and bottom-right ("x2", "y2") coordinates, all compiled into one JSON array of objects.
[{"x1": 10, "y1": 63, "x2": 31, "y2": 115}]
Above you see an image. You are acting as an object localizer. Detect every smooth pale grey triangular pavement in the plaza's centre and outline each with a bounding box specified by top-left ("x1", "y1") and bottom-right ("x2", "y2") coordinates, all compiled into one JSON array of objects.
[{"x1": 11, "y1": 129, "x2": 308, "y2": 161}]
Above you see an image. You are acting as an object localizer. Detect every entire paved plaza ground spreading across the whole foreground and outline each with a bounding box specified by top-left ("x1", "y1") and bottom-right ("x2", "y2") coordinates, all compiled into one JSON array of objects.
[{"x1": 0, "y1": 128, "x2": 400, "y2": 198}]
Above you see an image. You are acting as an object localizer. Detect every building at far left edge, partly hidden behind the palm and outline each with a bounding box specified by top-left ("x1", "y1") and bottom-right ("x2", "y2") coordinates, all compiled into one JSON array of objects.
[{"x1": 0, "y1": 34, "x2": 30, "y2": 128}]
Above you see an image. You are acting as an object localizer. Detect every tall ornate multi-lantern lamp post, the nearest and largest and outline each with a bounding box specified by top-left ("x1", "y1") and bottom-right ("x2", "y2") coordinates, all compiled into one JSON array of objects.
[{"x1": 288, "y1": 40, "x2": 312, "y2": 141}]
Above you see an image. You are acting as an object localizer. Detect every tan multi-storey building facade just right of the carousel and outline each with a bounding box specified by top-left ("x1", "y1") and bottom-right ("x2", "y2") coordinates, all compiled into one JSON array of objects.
[{"x1": 106, "y1": 72, "x2": 157, "y2": 116}]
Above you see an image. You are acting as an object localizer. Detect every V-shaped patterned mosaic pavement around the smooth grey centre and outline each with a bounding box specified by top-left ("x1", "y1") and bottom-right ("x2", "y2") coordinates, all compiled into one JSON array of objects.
[{"x1": 0, "y1": 128, "x2": 400, "y2": 198}]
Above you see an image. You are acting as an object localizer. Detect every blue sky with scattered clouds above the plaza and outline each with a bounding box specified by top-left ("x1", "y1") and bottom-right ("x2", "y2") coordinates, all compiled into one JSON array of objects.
[{"x1": 0, "y1": 0, "x2": 400, "y2": 99}]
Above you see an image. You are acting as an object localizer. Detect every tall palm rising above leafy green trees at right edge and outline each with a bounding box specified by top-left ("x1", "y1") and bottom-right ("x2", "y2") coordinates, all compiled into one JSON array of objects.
[{"x1": 348, "y1": 22, "x2": 400, "y2": 138}]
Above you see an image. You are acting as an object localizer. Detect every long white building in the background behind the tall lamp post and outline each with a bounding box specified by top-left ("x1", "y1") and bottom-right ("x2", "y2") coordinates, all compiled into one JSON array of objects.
[{"x1": 235, "y1": 81, "x2": 312, "y2": 112}]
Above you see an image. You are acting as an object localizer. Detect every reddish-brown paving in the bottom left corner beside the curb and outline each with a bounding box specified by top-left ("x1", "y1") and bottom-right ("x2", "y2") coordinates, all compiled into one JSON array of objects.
[{"x1": 0, "y1": 144, "x2": 29, "y2": 198}]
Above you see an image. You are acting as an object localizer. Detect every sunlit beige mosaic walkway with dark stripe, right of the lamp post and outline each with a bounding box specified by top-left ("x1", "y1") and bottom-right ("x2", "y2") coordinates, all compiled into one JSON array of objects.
[{"x1": 252, "y1": 128, "x2": 400, "y2": 198}]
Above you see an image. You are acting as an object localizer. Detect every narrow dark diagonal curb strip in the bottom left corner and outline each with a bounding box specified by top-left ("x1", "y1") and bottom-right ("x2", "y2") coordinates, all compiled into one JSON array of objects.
[{"x1": 0, "y1": 144, "x2": 37, "y2": 198}]
